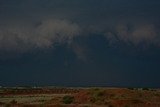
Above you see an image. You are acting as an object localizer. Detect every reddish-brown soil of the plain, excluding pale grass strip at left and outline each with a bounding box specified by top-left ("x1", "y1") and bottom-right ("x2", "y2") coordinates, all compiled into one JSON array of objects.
[{"x1": 0, "y1": 88, "x2": 160, "y2": 107}]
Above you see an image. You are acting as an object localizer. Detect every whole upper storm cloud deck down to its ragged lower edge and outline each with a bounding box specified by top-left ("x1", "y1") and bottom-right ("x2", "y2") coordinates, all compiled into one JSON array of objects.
[{"x1": 0, "y1": 0, "x2": 160, "y2": 50}]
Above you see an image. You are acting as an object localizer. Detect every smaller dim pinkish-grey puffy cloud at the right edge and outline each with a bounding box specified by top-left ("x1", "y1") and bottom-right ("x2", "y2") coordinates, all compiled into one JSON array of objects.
[{"x1": 105, "y1": 23, "x2": 160, "y2": 47}]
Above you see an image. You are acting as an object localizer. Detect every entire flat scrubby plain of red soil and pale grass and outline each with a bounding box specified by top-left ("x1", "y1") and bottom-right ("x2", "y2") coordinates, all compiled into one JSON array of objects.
[{"x1": 0, "y1": 88, "x2": 160, "y2": 107}]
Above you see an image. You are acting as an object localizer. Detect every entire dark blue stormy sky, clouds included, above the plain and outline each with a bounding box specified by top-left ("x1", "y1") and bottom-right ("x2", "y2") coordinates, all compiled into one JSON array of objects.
[{"x1": 0, "y1": 0, "x2": 160, "y2": 87}]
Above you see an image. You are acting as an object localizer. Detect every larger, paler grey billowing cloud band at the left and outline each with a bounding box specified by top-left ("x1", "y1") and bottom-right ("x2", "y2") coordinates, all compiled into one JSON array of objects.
[{"x1": 0, "y1": 19, "x2": 80, "y2": 52}]
